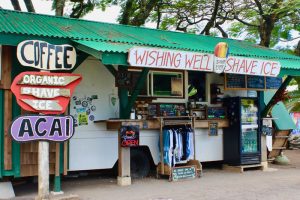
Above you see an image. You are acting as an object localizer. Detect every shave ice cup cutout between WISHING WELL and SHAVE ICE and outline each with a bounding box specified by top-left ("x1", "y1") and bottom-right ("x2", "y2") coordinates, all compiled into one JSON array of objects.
[{"x1": 214, "y1": 42, "x2": 229, "y2": 74}]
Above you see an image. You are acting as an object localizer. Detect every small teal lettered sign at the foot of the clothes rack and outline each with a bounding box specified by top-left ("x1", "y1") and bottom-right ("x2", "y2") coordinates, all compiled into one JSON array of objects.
[{"x1": 171, "y1": 165, "x2": 197, "y2": 181}]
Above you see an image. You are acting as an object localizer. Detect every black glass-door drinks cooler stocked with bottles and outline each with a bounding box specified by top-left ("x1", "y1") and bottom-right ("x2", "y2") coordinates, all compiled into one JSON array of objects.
[{"x1": 223, "y1": 97, "x2": 261, "y2": 165}]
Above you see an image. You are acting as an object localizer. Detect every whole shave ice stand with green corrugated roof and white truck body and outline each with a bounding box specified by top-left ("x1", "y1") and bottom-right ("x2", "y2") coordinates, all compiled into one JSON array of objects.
[{"x1": 0, "y1": 9, "x2": 300, "y2": 188}]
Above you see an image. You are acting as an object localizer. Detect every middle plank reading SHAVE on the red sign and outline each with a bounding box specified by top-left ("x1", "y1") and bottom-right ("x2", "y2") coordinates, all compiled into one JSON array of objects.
[{"x1": 21, "y1": 87, "x2": 71, "y2": 99}]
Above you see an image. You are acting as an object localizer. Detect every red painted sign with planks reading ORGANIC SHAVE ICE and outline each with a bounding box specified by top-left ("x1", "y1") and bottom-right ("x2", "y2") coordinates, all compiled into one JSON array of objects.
[{"x1": 11, "y1": 72, "x2": 82, "y2": 114}]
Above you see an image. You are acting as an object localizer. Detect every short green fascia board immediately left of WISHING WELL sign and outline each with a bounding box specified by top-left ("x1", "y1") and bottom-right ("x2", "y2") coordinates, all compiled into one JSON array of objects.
[{"x1": 102, "y1": 52, "x2": 129, "y2": 66}]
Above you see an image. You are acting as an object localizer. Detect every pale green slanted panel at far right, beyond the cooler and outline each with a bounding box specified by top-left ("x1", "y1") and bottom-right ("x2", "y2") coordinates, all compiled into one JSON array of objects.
[{"x1": 264, "y1": 91, "x2": 296, "y2": 130}]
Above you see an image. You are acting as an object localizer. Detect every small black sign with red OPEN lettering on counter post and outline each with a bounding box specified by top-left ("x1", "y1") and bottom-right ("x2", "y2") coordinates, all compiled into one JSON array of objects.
[{"x1": 120, "y1": 126, "x2": 140, "y2": 147}]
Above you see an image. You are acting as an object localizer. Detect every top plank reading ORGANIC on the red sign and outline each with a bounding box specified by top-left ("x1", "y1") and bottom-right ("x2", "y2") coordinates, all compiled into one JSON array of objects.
[{"x1": 18, "y1": 74, "x2": 80, "y2": 86}]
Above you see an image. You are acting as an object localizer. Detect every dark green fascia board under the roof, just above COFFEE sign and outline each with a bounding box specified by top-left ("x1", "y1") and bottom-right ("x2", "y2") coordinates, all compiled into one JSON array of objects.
[{"x1": 0, "y1": 33, "x2": 72, "y2": 46}]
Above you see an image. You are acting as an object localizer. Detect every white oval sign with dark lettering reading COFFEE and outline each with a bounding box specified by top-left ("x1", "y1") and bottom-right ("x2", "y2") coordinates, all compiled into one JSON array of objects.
[{"x1": 17, "y1": 40, "x2": 76, "y2": 70}]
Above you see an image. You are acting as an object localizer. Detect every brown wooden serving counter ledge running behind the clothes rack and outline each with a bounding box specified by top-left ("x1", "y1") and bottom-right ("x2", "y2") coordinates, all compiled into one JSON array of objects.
[{"x1": 106, "y1": 119, "x2": 229, "y2": 130}]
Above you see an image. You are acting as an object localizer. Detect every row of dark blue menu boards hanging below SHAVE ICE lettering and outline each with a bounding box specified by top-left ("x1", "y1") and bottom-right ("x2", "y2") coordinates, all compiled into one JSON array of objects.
[{"x1": 225, "y1": 74, "x2": 282, "y2": 90}]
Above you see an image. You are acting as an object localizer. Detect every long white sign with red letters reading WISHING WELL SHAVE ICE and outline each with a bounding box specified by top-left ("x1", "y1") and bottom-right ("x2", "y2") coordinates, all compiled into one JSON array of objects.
[{"x1": 128, "y1": 47, "x2": 280, "y2": 77}]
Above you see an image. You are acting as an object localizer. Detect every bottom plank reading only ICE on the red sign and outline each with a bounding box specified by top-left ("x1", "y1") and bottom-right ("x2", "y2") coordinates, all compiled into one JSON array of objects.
[{"x1": 21, "y1": 99, "x2": 62, "y2": 111}]
